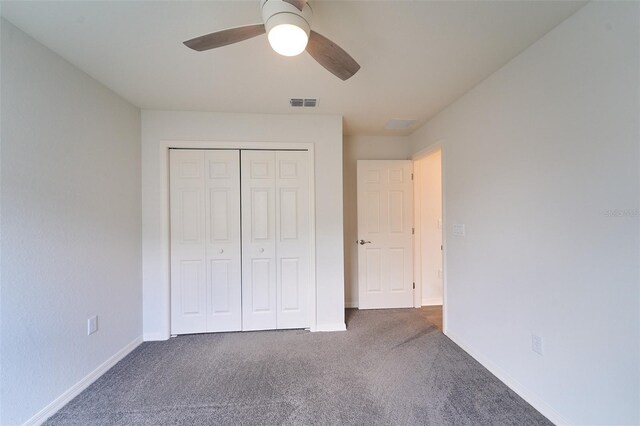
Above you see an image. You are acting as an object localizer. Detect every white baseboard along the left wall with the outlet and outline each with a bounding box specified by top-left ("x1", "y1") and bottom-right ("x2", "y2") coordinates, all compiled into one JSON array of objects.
[{"x1": 24, "y1": 337, "x2": 142, "y2": 426}]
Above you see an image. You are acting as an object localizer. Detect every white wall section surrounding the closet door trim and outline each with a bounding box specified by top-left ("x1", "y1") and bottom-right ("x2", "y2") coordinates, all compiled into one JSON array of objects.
[{"x1": 142, "y1": 110, "x2": 344, "y2": 340}]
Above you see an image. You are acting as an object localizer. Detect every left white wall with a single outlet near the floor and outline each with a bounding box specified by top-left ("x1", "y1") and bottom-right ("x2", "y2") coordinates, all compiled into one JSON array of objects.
[{"x1": 0, "y1": 21, "x2": 142, "y2": 425}]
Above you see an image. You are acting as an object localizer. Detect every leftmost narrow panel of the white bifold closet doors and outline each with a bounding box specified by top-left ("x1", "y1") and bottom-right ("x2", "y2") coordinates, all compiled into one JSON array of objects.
[{"x1": 169, "y1": 150, "x2": 207, "y2": 334}]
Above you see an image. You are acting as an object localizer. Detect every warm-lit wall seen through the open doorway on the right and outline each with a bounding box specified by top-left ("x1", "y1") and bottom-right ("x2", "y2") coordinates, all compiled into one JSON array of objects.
[{"x1": 414, "y1": 149, "x2": 444, "y2": 306}]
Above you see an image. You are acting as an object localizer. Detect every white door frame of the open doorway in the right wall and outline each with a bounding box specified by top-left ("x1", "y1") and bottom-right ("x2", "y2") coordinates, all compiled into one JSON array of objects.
[{"x1": 411, "y1": 140, "x2": 448, "y2": 334}]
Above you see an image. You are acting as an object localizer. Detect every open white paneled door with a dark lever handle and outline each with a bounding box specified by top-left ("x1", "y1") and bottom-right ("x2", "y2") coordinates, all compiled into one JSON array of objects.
[{"x1": 357, "y1": 160, "x2": 413, "y2": 309}]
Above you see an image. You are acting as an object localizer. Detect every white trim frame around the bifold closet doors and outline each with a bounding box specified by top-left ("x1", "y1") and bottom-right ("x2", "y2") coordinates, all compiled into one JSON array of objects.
[{"x1": 158, "y1": 140, "x2": 318, "y2": 337}]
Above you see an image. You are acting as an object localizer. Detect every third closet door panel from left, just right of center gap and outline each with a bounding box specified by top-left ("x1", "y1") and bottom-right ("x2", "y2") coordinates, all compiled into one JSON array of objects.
[{"x1": 241, "y1": 151, "x2": 277, "y2": 330}]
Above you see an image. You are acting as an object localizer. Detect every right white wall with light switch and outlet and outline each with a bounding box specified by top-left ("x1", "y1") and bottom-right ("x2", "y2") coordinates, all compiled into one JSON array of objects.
[{"x1": 412, "y1": 2, "x2": 640, "y2": 425}]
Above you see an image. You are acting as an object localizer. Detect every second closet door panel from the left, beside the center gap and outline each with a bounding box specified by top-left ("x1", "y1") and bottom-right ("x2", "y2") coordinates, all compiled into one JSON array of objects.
[{"x1": 204, "y1": 150, "x2": 242, "y2": 332}]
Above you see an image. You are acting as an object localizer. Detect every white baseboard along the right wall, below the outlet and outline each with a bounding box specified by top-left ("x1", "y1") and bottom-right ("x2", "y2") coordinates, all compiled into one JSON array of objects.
[{"x1": 445, "y1": 332, "x2": 572, "y2": 426}]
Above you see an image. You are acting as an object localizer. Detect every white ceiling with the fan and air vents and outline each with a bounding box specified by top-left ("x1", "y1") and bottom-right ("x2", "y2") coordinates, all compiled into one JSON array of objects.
[{"x1": 1, "y1": 0, "x2": 585, "y2": 135}]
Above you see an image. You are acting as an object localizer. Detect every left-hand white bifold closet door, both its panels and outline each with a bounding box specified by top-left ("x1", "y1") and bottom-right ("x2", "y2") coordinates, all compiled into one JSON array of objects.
[{"x1": 169, "y1": 149, "x2": 242, "y2": 334}]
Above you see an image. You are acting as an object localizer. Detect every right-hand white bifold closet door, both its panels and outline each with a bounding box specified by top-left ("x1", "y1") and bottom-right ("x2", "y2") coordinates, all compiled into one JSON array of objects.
[{"x1": 241, "y1": 151, "x2": 310, "y2": 330}]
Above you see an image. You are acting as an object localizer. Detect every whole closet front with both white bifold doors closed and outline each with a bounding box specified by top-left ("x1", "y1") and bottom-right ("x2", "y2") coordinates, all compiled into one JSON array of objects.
[{"x1": 169, "y1": 149, "x2": 311, "y2": 334}]
